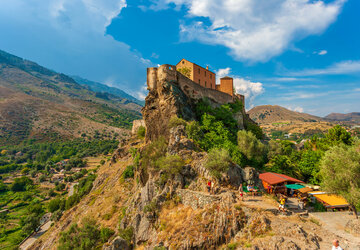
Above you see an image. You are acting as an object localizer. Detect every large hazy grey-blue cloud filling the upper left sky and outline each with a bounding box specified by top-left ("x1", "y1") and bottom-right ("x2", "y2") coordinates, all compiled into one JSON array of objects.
[{"x1": 0, "y1": 0, "x2": 151, "y2": 94}]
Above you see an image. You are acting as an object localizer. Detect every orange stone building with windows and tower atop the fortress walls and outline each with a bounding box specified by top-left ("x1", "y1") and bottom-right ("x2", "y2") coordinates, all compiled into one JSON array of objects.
[{"x1": 176, "y1": 59, "x2": 245, "y2": 103}]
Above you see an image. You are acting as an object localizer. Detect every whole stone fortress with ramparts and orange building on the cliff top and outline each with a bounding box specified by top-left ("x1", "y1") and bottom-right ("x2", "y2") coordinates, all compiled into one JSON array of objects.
[{"x1": 147, "y1": 59, "x2": 245, "y2": 106}]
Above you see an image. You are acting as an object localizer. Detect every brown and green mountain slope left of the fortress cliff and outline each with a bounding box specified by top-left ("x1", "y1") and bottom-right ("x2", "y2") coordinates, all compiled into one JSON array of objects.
[{"x1": 0, "y1": 50, "x2": 141, "y2": 145}]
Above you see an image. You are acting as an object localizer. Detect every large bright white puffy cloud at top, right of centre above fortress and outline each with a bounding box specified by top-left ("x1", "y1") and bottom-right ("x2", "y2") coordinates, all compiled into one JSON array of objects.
[{"x1": 157, "y1": 0, "x2": 346, "y2": 62}]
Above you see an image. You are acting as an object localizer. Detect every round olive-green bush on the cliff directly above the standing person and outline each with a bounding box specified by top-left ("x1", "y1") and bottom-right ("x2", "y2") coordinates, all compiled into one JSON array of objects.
[{"x1": 205, "y1": 148, "x2": 230, "y2": 179}]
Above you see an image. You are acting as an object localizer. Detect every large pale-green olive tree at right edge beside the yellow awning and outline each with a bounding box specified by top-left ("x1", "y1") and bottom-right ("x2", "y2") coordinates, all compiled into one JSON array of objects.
[{"x1": 320, "y1": 143, "x2": 360, "y2": 218}]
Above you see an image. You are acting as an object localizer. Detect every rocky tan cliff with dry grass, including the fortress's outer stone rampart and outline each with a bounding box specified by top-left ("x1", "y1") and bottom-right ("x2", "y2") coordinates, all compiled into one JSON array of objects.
[{"x1": 32, "y1": 65, "x2": 360, "y2": 250}]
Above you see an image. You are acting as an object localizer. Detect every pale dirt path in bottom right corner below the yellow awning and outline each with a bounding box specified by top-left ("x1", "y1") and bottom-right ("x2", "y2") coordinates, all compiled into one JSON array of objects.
[{"x1": 309, "y1": 212, "x2": 360, "y2": 250}]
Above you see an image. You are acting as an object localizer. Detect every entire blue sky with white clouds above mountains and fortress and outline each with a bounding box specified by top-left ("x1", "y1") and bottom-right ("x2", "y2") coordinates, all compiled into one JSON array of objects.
[{"x1": 0, "y1": 0, "x2": 360, "y2": 116}]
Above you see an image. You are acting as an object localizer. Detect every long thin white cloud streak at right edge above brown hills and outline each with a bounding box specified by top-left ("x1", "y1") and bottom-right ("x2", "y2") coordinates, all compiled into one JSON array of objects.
[{"x1": 287, "y1": 60, "x2": 360, "y2": 76}]
